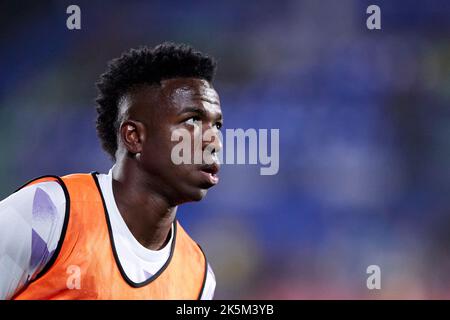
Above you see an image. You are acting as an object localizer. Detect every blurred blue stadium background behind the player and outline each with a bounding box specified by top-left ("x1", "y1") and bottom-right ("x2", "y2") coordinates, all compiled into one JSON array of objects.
[{"x1": 0, "y1": 0, "x2": 450, "y2": 299}]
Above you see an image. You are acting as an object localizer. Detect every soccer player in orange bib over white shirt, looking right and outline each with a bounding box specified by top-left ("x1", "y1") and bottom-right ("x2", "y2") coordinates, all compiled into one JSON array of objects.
[{"x1": 0, "y1": 43, "x2": 222, "y2": 299}]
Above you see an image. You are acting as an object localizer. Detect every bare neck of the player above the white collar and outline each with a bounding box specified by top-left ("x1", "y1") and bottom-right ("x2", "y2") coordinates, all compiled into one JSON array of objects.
[{"x1": 112, "y1": 160, "x2": 177, "y2": 250}]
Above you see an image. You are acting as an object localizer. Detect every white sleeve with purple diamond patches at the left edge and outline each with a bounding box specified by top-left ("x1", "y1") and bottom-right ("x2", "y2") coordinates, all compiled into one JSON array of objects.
[{"x1": 0, "y1": 181, "x2": 66, "y2": 300}]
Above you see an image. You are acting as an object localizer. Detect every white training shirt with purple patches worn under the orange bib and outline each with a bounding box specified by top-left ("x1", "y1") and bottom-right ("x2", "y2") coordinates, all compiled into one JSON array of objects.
[{"x1": 0, "y1": 169, "x2": 216, "y2": 300}]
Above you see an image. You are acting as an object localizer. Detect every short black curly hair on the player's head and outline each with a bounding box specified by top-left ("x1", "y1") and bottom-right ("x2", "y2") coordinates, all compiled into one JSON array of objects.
[{"x1": 95, "y1": 42, "x2": 216, "y2": 161}]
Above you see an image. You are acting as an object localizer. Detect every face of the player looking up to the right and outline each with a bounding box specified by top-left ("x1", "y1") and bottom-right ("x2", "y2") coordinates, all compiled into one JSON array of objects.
[{"x1": 121, "y1": 78, "x2": 222, "y2": 204}]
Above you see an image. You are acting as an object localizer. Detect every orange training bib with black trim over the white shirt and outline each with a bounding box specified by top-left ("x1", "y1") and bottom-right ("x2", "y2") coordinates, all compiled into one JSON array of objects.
[{"x1": 14, "y1": 174, "x2": 207, "y2": 300}]
